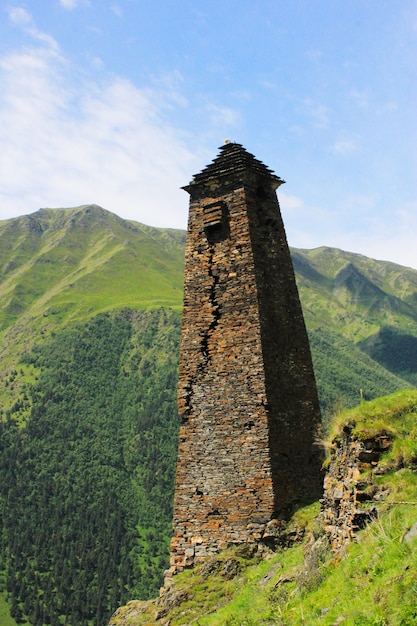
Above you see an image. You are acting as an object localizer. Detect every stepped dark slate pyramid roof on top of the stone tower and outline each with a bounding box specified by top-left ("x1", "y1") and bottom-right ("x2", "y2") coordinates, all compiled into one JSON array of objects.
[{"x1": 183, "y1": 140, "x2": 285, "y2": 190}]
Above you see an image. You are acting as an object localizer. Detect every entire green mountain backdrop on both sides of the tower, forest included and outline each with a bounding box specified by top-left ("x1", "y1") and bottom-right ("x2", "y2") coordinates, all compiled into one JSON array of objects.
[{"x1": 0, "y1": 205, "x2": 417, "y2": 626}]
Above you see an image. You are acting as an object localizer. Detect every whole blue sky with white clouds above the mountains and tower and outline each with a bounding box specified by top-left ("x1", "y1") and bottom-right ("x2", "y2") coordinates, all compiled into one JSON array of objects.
[{"x1": 0, "y1": 0, "x2": 417, "y2": 268}]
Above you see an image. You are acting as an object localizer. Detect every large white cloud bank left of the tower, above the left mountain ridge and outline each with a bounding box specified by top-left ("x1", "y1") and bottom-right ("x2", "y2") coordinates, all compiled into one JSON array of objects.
[{"x1": 0, "y1": 37, "x2": 206, "y2": 227}]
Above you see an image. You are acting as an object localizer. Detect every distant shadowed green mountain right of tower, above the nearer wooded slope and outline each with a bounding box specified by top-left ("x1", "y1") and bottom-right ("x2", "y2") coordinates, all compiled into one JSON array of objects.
[{"x1": 293, "y1": 248, "x2": 417, "y2": 384}]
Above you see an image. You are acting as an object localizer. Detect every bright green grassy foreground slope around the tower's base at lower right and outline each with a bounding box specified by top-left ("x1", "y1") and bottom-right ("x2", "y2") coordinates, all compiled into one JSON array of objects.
[{"x1": 121, "y1": 391, "x2": 417, "y2": 626}]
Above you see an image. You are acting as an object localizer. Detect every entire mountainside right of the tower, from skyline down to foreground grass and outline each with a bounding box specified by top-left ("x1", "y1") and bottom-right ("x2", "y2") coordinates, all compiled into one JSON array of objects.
[{"x1": 292, "y1": 247, "x2": 417, "y2": 415}]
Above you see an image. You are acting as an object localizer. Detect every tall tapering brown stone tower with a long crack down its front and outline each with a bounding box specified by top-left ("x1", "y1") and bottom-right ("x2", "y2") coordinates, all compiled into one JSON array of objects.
[{"x1": 171, "y1": 142, "x2": 322, "y2": 571}]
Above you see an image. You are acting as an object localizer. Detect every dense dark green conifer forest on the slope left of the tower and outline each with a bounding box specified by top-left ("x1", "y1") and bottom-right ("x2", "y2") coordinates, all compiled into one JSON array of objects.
[{"x1": 0, "y1": 308, "x2": 180, "y2": 626}]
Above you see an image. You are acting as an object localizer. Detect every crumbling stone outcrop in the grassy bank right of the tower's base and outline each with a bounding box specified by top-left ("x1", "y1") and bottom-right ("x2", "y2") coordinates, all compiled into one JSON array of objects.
[{"x1": 321, "y1": 425, "x2": 391, "y2": 554}]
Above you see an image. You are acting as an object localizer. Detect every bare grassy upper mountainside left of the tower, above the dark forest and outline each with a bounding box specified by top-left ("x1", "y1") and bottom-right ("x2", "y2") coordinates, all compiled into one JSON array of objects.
[{"x1": 0, "y1": 205, "x2": 185, "y2": 328}]
